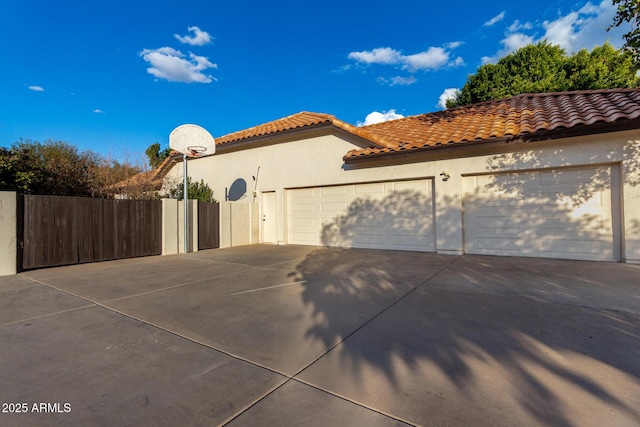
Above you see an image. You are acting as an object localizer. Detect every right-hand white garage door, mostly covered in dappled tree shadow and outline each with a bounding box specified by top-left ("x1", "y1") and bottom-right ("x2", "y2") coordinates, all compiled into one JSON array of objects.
[{"x1": 463, "y1": 166, "x2": 620, "y2": 261}]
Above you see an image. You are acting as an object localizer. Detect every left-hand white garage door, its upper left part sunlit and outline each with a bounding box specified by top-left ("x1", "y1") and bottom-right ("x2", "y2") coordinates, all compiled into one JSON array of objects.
[{"x1": 287, "y1": 179, "x2": 435, "y2": 252}]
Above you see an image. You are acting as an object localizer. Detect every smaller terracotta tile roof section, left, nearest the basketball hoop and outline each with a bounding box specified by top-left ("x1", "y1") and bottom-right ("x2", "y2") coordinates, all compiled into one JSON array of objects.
[{"x1": 215, "y1": 111, "x2": 387, "y2": 147}]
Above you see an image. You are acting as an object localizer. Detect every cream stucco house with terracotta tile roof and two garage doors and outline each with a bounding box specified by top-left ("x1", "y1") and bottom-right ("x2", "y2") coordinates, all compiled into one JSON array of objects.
[{"x1": 165, "y1": 89, "x2": 640, "y2": 263}]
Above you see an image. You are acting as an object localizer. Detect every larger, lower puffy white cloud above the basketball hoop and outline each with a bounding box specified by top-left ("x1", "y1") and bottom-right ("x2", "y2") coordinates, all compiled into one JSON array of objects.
[{"x1": 140, "y1": 47, "x2": 218, "y2": 83}]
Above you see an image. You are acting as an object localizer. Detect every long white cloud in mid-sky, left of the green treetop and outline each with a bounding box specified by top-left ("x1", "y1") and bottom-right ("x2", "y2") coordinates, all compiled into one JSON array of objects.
[{"x1": 349, "y1": 42, "x2": 464, "y2": 72}]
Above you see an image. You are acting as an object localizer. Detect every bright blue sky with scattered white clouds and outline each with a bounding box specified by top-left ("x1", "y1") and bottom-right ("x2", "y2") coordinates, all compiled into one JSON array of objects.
[{"x1": 0, "y1": 0, "x2": 628, "y2": 161}]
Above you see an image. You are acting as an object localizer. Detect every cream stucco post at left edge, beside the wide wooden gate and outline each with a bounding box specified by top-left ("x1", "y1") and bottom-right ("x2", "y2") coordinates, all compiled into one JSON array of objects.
[{"x1": 0, "y1": 191, "x2": 18, "y2": 276}]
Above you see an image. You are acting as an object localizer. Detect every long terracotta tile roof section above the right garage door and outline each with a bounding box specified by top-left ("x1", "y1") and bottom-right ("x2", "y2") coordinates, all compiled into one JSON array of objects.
[{"x1": 344, "y1": 88, "x2": 640, "y2": 162}]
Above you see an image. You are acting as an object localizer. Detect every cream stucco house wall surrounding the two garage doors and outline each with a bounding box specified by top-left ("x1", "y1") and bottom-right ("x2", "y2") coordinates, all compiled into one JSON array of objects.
[{"x1": 162, "y1": 131, "x2": 640, "y2": 262}]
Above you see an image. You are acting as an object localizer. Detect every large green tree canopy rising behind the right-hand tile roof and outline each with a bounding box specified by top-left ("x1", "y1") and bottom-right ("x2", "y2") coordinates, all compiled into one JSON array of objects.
[{"x1": 447, "y1": 41, "x2": 640, "y2": 108}]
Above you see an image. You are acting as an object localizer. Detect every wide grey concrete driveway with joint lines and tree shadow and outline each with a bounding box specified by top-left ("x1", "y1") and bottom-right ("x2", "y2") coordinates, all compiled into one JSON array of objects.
[{"x1": 0, "y1": 245, "x2": 640, "y2": 426}]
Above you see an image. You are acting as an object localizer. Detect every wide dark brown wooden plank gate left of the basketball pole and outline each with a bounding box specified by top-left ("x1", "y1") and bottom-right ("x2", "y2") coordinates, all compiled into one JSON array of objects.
[{"x1": 18, "y1": 195, "x2": 162, "y2": 270}]
